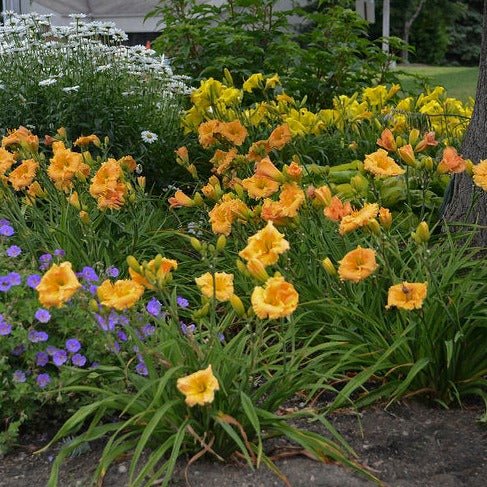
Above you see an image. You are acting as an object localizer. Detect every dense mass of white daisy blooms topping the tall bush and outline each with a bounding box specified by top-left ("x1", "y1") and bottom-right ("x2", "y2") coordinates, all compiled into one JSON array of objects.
[{"x1": 0, "y1": 12, "x2": 190, "y2": 98}]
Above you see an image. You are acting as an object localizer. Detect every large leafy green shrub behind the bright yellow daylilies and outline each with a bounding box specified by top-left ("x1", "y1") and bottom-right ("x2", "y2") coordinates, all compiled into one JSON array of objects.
[{"x1": 149, "y1": 0, "x2": 404, "y2": 106}]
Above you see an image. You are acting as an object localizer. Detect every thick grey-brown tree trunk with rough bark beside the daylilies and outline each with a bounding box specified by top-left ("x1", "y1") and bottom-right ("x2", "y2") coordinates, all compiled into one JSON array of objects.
[{"x1": 443, "y1": 1, "x2": 487, "y2": 247}]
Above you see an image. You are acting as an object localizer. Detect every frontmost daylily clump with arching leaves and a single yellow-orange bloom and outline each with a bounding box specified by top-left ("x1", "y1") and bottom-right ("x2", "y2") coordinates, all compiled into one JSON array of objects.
[{"x1": 39, "y1": 282, "x2": 377, "y2": 487}]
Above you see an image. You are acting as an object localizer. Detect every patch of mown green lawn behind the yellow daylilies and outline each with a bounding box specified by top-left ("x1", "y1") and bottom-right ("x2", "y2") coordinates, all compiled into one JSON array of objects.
[{"x1": 397, "y1": 64, "x2": 479, "y2": 101}]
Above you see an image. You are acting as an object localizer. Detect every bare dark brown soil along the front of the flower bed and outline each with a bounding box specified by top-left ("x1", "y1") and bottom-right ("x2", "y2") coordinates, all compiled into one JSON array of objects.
[{"x1": 0, "y1": 402, "x2": 487, "y2": 487}]
